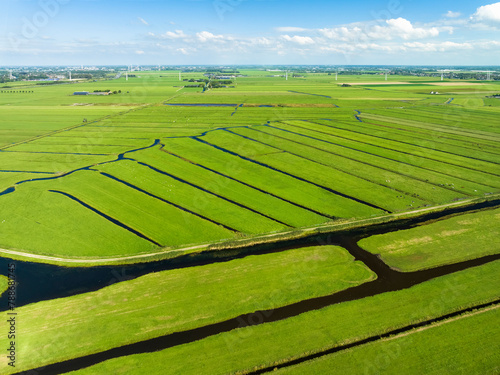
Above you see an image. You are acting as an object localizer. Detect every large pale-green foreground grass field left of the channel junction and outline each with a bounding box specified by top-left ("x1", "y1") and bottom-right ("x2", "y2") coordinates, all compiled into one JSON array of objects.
[{"x1": 2, "y1": 246, "x2": 375, "y2": 371}]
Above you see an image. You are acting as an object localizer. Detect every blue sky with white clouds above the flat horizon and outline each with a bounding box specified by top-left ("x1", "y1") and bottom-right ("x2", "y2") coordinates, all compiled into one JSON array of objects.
[{"x1": 0, "y1": 0, "x2": 500, "y2": 65}]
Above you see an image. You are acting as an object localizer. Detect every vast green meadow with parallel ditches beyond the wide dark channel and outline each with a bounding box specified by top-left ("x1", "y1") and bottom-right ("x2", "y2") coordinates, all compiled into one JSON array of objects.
[{"x1": 0, "y1": 70, "x2": 500, "y2": 259}]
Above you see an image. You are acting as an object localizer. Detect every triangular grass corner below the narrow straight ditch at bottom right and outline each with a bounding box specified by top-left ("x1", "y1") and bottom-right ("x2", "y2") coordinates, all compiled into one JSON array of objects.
[{"x1": 276, "y1": 307, "x2": 500, "y2": 375}]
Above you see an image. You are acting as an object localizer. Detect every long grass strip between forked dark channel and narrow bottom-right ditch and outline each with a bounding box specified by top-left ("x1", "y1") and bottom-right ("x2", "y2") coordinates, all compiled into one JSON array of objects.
[{"x1": 66, "y1": 261, "x2": 500, "y2": 375}]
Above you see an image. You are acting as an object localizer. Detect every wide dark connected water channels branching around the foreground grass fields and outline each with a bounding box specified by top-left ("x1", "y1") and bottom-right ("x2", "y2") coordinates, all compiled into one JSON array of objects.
[{"x1": 0, "y1": 199, "x2": 500, "y2": 374}]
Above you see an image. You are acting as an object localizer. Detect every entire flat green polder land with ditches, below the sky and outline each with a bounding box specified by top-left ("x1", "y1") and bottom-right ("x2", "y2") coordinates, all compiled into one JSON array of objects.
[{"x1": 0, "y1": 67, "x2": 500, "y2": 375}]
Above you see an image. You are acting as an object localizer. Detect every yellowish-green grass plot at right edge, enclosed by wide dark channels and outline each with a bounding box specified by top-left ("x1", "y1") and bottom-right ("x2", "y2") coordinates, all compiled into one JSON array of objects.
[{"x1": 359, "y1": 209, "x2": 500, "y2": 272}]
